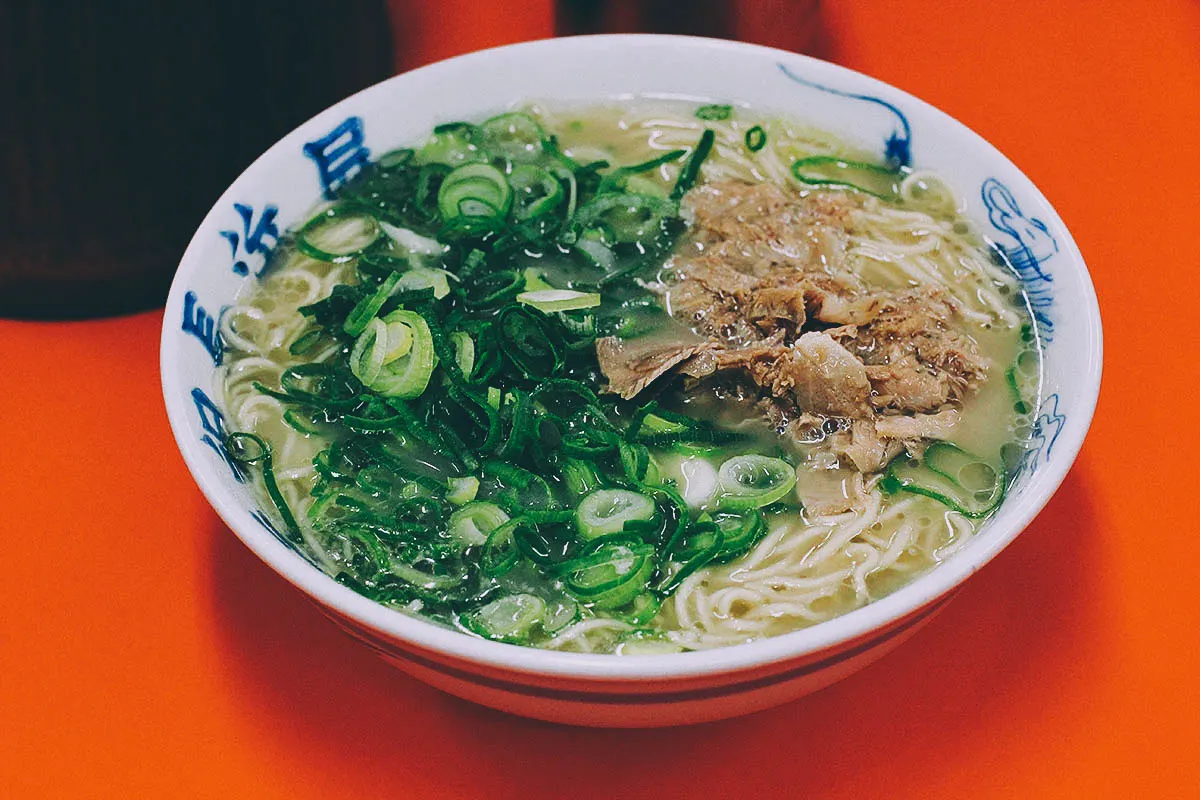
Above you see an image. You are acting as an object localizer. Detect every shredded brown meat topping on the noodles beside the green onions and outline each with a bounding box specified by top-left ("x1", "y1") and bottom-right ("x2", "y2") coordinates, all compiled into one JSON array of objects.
[{"x1": 596, "y1": 180, "x2": 988, "y2": 471}]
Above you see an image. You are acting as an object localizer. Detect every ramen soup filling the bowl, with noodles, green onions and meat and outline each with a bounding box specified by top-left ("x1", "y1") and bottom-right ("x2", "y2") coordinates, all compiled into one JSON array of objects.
[{"x1": 220, "y1": 101, "x2": 1040, "y2": 654}]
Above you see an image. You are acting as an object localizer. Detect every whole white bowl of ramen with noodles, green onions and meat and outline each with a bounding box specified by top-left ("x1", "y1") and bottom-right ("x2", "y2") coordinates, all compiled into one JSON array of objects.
[{"x1": 162, "y1": 36, "x2": 1100, "y2": 726}]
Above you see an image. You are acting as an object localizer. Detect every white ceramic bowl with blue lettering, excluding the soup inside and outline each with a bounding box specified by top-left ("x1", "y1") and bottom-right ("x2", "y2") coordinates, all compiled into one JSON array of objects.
[{"x1": 162, "y1": 36, "x2": 1100, "y2": 726}]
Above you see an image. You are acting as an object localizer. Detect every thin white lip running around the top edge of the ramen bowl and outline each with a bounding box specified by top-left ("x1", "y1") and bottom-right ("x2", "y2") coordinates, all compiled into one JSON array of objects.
[{"x1": 160, "y1": 34, "x2": 1103, "y2": 682}]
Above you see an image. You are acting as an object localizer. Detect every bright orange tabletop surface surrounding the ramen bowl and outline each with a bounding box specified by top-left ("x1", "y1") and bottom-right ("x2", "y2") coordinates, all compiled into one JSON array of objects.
[{"x1": 0, "y1": 0, "x2": 1200, "y2": 800}]
